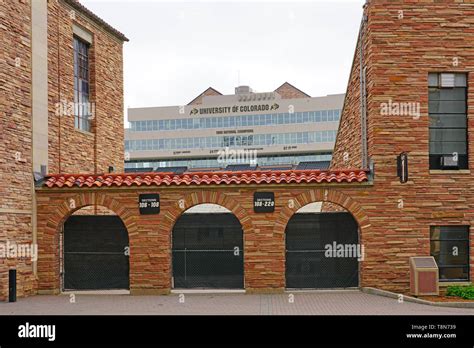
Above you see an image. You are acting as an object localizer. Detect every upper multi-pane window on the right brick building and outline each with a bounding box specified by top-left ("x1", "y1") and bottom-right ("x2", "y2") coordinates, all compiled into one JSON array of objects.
[{"x1": 429, "y1": 73, "x2": 468, "y2": 170}]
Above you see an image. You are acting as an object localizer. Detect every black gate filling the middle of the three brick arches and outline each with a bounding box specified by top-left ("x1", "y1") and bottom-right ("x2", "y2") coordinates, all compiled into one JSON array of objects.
[{"x1": 173, "y1": 214, "x2": 244, "y2": 289}]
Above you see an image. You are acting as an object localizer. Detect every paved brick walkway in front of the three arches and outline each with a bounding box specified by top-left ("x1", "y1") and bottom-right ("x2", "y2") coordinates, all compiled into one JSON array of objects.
[{"x1": 0, "y1": 291, "x2": 474, "y2": 315}]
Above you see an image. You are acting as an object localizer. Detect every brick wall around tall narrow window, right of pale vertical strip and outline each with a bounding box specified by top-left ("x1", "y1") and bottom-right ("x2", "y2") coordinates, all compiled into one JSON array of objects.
[{"x1": 48, "y1": 1, "x2": 124, "y2": 173}]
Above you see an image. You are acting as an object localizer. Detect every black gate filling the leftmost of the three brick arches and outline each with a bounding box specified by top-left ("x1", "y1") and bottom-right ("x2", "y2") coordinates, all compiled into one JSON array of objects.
[{"x1": 63, "y1": 215, "x2": 129, "y2": 290}]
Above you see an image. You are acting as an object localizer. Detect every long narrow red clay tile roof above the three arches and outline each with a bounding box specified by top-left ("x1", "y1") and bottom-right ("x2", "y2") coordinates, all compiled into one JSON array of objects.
[{"x1": 44, "y1": 169, "x2": 368, "y2": 188}]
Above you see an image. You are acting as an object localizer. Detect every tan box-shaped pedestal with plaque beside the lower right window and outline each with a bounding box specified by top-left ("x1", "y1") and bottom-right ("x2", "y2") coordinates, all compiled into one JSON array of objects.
[{"x1": 410, "y1": 256, "x2": 439, "y2": 296}]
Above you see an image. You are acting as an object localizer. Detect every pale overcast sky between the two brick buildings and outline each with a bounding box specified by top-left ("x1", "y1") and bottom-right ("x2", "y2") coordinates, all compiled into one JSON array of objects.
[{"x1": 81, "y1": 0, "x2": 365, "y2": 108}]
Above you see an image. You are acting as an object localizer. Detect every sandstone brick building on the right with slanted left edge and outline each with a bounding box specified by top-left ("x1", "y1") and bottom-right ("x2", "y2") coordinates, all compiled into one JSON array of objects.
[{"x1": 332, "y1": 0, "x2": 474, "y2": 290}]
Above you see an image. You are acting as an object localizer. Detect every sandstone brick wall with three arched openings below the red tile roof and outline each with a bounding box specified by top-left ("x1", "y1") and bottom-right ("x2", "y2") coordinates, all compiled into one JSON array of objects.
[{"x1": 37, "y1": 184, "x2": 373, "y2": 294}]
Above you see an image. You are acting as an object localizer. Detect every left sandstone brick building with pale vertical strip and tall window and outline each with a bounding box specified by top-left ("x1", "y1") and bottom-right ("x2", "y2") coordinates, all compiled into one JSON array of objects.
[{"x1": 0, "y1": 0, "x2": 128, "y2": 299}]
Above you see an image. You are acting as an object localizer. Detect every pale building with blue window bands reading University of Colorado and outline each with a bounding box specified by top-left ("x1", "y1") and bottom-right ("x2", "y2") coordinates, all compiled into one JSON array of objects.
[{"x1": 125, "y1": 83, "x2": 344, "y2": 171}]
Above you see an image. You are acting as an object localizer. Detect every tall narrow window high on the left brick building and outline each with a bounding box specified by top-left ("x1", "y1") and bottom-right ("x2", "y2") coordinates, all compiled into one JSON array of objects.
[{"x1": 74, "y1": 36, "x2": 92, "y2": 132}]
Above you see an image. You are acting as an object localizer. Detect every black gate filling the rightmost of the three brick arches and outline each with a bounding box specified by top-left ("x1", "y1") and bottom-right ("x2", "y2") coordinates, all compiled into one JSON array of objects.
[{"x1": 286, "y1": 213, "x2": 363, "y2": 289}]
